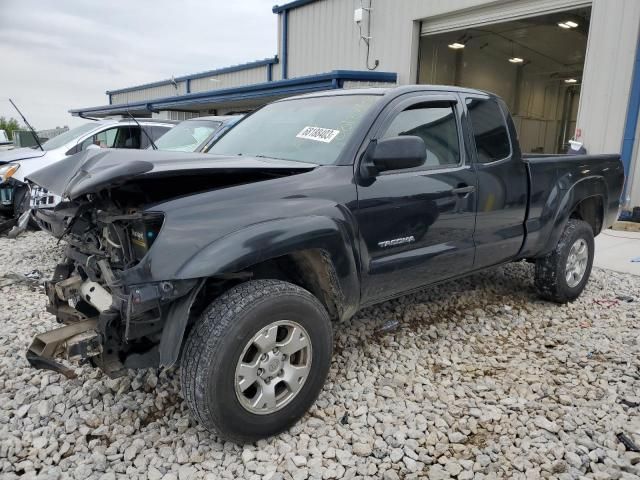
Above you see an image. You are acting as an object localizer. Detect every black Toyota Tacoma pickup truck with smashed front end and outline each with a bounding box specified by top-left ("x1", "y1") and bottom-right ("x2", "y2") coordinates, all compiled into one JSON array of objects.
[{"x1": 27, "y1": 86, "x2": 624, "y2": 441}]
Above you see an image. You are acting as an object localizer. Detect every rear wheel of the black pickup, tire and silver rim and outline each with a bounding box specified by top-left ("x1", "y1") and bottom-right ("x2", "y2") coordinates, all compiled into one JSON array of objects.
[{"x1": 535, "y1": 219, "x2": 594, "y2": 303}]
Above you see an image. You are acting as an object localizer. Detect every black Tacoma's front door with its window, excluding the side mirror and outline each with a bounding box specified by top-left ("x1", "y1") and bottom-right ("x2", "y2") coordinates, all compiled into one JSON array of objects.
[{"x1": 355, "y1": 94, "x2": 477, "y2": 304}]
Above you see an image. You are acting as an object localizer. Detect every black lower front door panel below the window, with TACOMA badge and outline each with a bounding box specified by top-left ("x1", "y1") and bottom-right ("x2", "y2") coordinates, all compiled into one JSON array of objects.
[{"x1": 356, "y1": 166, "x2": 476, "y2": 302}]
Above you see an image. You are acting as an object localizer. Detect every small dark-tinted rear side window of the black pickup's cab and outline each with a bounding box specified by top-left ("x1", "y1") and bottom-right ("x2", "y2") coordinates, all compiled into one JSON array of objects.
[{"x1": 466, "y1": 98, "x2": 511, "y2": 163}]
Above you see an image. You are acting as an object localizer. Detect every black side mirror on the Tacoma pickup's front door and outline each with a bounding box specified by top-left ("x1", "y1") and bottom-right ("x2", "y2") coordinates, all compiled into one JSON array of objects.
[{"x1": 360, "y1": 135, "x2": 427, "y2": 178}]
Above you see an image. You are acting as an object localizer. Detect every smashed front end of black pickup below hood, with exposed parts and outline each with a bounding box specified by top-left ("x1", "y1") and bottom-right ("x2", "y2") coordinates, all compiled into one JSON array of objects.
[{"x1": 27, "y1": 202, "x2": 199, "y2": 377}]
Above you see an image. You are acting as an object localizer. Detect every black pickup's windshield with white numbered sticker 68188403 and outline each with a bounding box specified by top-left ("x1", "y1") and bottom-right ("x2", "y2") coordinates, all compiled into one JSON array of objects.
[{"x1": 209, "y1": 95, "x2": 380, "y2": 165}]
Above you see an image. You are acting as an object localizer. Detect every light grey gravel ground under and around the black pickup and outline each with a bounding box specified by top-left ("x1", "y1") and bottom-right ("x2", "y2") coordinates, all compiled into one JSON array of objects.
[{"x1": 0, "y1": 232, "x2": 640, "y2": 480}]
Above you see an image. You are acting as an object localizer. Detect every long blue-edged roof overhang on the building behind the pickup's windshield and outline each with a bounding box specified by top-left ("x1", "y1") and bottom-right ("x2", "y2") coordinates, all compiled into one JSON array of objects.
[{"x1": 69, "y1": 70, "x2": 397, "y2": 117}]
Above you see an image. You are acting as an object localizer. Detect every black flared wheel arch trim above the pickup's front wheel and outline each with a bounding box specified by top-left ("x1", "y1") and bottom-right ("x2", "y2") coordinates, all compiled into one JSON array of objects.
[{"x1": 176, "y1": 216, "x2": 360, "y2": 316}]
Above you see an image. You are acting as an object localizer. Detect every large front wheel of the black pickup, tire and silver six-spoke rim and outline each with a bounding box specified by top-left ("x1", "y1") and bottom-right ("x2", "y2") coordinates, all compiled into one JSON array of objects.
[{"x1": 180, "y1": 280, "x2": 333, "y2": 443}]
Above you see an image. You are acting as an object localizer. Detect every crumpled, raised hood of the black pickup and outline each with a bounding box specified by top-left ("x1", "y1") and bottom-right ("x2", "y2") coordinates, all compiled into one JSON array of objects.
[{"x1": 27, "y1": 150, "x2": 317, "y2": 200}]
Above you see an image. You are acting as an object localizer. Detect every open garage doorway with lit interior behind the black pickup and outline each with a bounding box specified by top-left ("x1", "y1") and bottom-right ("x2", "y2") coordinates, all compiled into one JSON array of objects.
[{"x1": 418, "y1": 7, "x2": 591, "y2": 153}]
